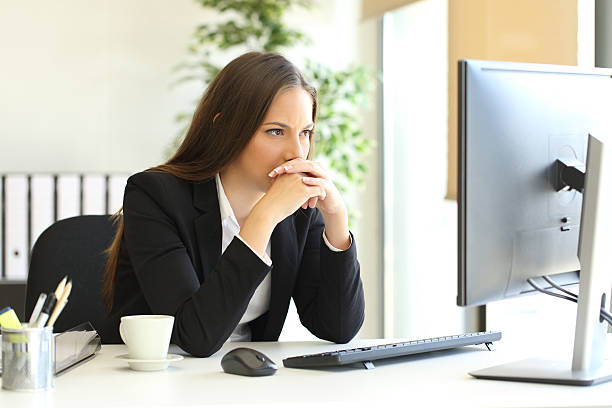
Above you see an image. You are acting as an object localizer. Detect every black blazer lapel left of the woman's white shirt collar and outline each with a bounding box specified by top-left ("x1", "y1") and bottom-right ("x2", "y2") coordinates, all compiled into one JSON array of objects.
[{"x1": 193, "y1": 178, "x2": 222, "y2": 282}]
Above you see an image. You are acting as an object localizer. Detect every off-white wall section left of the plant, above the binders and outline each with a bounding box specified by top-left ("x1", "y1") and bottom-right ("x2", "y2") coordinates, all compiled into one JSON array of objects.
[{"x1": 0, "y1": 0, "x2": 210, "y2": 171}]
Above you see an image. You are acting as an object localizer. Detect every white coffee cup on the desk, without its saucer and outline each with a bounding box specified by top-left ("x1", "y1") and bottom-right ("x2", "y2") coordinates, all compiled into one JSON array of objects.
[{"x1": 119, "y1": 315, "x2": 174, "y2": 360}]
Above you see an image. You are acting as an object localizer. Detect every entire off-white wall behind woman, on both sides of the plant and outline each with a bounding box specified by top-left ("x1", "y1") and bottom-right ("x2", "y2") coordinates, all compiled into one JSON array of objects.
[{"x1": 0, "y1": 0, "x2": 382, "y2": 337}]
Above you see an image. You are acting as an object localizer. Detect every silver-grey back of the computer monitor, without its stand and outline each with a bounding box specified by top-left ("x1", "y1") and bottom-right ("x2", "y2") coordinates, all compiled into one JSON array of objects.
[{"x1": 457, "y1": 60, "x2": 612, "y2": 306}]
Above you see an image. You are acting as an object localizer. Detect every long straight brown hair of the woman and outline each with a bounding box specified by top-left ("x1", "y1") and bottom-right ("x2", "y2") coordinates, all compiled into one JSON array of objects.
[{"x1": 102, "y1": 52, "x2": 317, "y2": 312}]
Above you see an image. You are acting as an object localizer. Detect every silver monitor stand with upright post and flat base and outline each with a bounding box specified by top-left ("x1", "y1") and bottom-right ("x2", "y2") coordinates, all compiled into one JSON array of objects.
[{"x1": 469, "y1": 135, "x2": 612, "y2": 385}]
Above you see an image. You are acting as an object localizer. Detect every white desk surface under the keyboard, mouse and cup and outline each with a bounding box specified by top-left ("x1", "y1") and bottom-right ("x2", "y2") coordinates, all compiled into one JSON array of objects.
[{"x1": 0, "y1": 337, "x2": 612, "y2": 408}]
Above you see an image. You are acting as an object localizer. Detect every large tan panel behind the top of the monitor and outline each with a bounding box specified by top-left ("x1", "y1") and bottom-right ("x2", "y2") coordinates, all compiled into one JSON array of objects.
[{"x1": 446, "y1": 0, "x2": 578, "y2": 199}]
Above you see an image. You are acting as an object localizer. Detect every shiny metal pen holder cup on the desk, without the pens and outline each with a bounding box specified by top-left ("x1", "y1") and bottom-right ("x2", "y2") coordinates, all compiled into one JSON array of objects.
[{"x1": 2, "y1": 326, "x2": 55, "y2": 391}]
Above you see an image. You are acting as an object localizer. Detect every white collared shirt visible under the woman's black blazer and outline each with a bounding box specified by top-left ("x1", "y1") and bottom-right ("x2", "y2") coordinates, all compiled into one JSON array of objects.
[{"x1": 215, "y1": 174, "x2": 353, "y2": 341}]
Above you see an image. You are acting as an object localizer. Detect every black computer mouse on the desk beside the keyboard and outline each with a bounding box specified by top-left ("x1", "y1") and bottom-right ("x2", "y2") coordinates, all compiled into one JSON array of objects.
[{"x1": 221, "y1": 347, "x2": 278, "y2": 377}]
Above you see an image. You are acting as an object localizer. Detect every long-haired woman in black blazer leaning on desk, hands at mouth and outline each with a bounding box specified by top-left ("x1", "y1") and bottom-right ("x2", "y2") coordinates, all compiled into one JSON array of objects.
[{"x1": 101, "y1": 52, "x2": 364, "y2": 356}]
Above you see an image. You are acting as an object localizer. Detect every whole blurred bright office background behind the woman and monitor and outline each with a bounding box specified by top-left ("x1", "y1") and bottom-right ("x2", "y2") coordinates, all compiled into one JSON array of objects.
[{"x1": 0, "y1": 0, "x2": 612, "y2": 340}]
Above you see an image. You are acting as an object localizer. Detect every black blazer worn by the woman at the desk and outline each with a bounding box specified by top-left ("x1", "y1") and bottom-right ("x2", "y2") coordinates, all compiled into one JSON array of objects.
[{"x1": 100, "y1": 172, "x2": 364, "y2": 356}]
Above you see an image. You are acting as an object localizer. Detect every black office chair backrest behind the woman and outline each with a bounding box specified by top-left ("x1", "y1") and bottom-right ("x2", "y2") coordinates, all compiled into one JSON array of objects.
[{"x1": 25, "y1": 215, "x2": 116, "y2": 332}]
